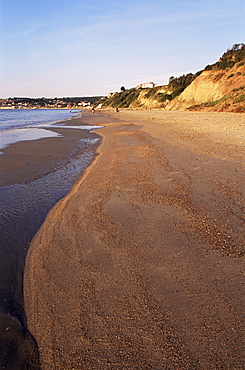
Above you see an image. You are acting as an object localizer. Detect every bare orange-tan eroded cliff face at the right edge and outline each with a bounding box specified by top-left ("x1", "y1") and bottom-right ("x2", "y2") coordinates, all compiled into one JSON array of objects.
[{"x1": 166, "y1": 63, "x2": 245, "y2": 112}]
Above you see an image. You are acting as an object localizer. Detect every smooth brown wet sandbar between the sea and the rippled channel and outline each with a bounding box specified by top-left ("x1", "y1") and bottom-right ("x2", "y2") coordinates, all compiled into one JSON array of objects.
[{"x1": 0, "y1": 113, "x2": 110, "y2": 186}]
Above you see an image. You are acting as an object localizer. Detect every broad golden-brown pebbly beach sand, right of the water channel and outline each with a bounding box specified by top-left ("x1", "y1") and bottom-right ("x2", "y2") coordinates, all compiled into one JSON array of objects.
[{"x1": 24, "y1": 110, "x2": 245, "y2": 370}]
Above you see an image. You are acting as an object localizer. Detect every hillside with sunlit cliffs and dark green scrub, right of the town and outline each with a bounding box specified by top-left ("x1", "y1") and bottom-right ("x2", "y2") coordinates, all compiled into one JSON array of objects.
[{"x1": 99, "y1": 44, "x2": 245, "y2": 112}]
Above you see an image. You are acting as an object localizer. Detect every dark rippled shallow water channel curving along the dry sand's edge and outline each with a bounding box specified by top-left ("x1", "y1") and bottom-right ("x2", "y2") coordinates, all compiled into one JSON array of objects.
[{"x1": 0, "y1": 133, "x2": 101, "y2": 369}]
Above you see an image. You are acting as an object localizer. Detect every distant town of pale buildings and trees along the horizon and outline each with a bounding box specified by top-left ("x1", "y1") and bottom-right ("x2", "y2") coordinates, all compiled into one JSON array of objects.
[{"x1": 0, "y1": 96, "x2": 102, "y2": 109}]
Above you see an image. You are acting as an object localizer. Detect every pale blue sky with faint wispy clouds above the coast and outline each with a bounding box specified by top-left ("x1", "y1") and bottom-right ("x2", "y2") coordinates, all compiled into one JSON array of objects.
[{"x1": 0, "y1": 0, "x2": 245, "y2": 98}]
